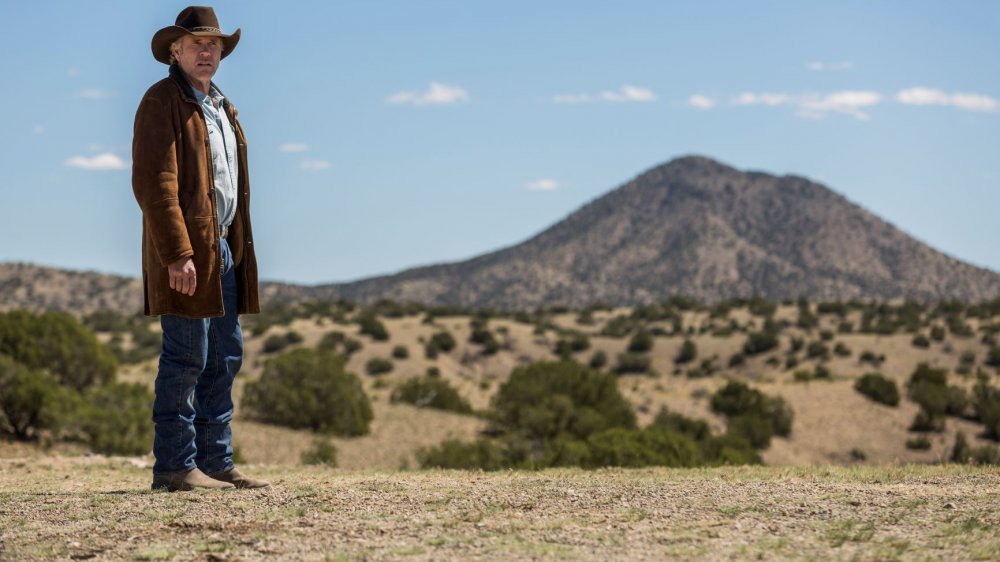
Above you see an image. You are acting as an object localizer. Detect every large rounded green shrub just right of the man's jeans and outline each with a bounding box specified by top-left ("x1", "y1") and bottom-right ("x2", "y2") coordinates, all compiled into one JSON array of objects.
[{"x1": 243, "y1": 349, "x2": 372, "y2": 436}]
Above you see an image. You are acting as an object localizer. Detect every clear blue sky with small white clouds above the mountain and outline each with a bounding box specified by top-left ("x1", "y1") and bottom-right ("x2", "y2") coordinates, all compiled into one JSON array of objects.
[{"x1": 0, "y1": 0, "x2": 1000, "y2": 283}]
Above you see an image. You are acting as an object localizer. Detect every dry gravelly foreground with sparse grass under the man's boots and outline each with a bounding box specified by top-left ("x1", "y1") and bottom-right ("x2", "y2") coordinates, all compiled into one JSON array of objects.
[{"x1": 0, "y1": 457, "x2": 1000, "y2": 561}]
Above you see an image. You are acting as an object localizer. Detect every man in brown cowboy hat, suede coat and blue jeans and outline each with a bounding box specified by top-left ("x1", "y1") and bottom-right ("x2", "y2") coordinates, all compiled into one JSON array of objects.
[{"x1": 132, "y1": 6, "x2": 268, "y2": 491}]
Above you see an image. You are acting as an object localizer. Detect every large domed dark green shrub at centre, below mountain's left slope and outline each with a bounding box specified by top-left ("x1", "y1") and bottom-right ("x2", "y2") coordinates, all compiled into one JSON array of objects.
[{"x1": 493, "y1": 361, "x2": 635, "y2": 439}]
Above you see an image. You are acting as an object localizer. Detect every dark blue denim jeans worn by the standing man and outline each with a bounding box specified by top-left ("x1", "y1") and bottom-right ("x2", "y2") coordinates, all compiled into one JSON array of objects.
[{"x1": 153, "y1": 235, "x2": 243, "y2": 474}]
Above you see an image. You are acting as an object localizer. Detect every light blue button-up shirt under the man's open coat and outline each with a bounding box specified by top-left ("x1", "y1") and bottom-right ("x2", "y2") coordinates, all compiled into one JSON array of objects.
[{"x1": 192, "y1": 84, "x2": 239, "y2": 230}]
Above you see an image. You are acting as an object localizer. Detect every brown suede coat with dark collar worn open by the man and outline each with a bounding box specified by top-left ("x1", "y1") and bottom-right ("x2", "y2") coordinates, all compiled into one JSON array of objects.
[{"x1": 132, "y1": 66, "x2": 260, "y2": 318}]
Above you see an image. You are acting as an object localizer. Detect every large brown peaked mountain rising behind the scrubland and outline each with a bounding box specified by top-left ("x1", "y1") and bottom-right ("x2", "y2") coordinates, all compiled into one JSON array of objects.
[{"x1": 271, "y1": 156, "x2": 1000, "y2": 308}]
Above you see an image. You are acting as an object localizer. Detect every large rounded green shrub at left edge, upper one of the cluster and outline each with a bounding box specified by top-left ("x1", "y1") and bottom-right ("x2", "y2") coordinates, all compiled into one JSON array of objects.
[{"x1": 0, "y1": 310, "x2": 118, "y2": 390}]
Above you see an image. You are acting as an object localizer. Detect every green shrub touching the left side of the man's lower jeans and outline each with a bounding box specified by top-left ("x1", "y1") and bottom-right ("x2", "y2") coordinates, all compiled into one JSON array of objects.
[{"x1": 75, "y1": 383, "x2": 153, "y2": 455}]
